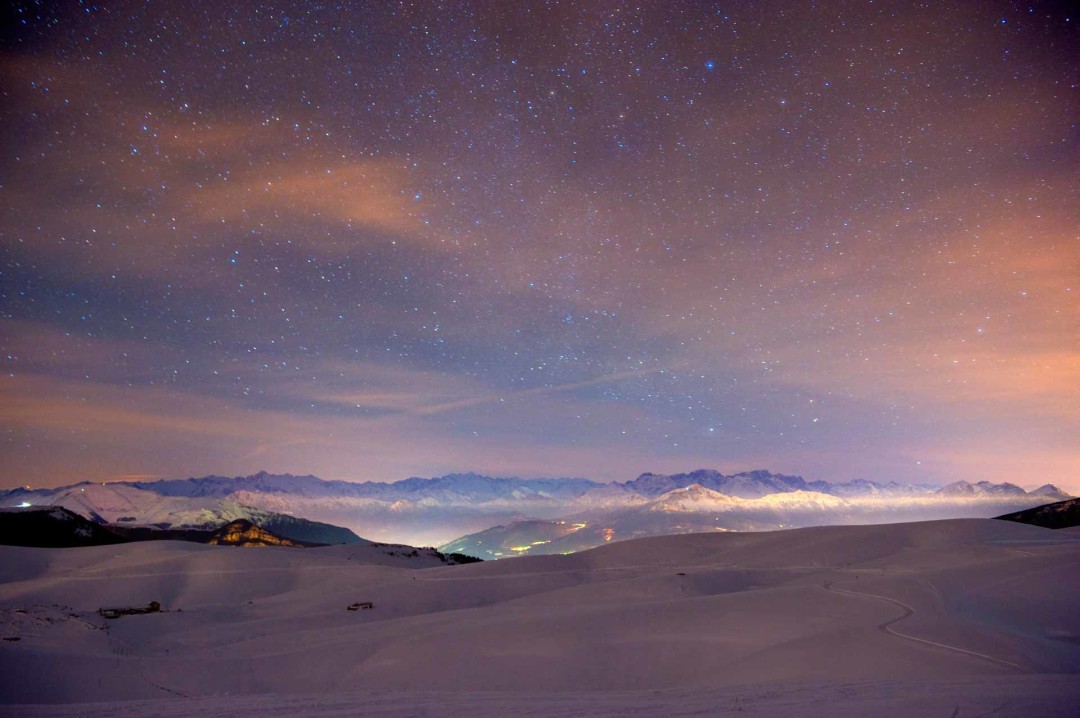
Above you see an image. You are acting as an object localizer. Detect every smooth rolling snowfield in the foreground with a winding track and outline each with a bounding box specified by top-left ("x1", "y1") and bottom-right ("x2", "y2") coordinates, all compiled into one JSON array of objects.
[{"x1": 0, "y1": 520, "x2": 1080, "y2": 717}]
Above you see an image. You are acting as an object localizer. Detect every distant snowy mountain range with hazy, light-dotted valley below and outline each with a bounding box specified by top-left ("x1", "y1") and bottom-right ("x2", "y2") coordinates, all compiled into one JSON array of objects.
[{"x1": 0, "y1": 469, "x2": 1069, "y2": 550}]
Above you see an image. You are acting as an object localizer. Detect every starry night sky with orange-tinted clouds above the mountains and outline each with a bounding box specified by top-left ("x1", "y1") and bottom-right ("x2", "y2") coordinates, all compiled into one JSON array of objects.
[{"x1": 0, "y1": 0, "x2": 1080, "y2": 490}]
